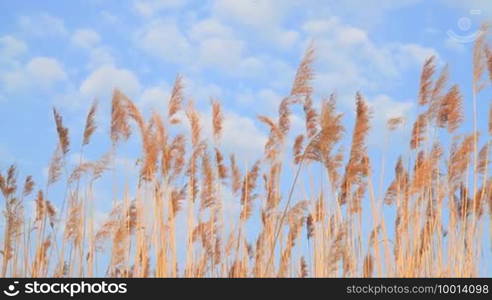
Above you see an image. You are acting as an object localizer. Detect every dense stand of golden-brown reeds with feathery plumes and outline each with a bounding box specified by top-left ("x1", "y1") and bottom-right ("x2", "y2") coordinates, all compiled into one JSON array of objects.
[{"x1": 0, "y1": 27, "x2": 492, "y2": 277}]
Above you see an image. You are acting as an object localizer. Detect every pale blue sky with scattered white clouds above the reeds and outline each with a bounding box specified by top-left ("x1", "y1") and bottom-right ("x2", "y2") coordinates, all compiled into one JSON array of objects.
[{"x1": 0, "y1": 0, "x2": 492, "y2": 276}]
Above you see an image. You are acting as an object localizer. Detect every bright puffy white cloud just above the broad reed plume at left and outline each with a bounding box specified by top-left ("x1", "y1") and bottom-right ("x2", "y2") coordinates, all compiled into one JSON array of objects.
[{"x1": 80, "y1": 65, "x2": 140, "y2": 99}]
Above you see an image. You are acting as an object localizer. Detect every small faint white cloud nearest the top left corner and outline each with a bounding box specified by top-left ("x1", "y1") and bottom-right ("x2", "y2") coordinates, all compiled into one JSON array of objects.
[{"x1": 18, "y1": 13, "x2": 68, "y2": 37}]
